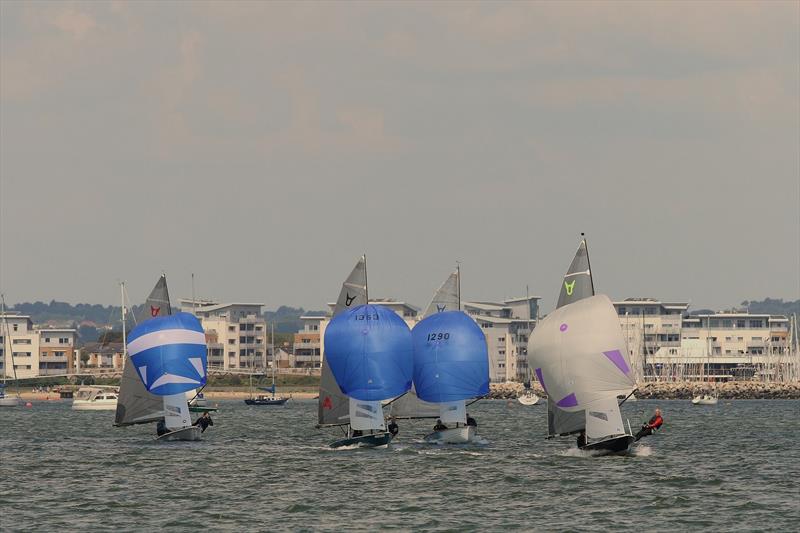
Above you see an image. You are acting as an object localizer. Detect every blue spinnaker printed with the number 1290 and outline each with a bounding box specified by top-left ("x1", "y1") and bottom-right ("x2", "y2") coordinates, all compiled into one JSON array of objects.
[{"x1": 411, "y1": 311, "x2": 489, "y2": 403}]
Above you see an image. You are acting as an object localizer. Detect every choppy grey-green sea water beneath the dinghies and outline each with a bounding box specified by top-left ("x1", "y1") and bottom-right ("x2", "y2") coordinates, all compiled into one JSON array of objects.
[{"x1": 0, "y1": 401, "x2": 800, "y2": 531}]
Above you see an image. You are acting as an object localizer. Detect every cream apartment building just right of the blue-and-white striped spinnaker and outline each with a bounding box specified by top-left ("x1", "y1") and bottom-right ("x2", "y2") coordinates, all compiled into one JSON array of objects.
[{"x1": 180, "y1": 299, "x2": 269, "y2": 371}]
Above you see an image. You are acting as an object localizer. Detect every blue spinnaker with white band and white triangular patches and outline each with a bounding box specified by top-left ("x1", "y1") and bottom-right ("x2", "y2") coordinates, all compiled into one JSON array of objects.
[{"x1": 128, "y1": 313, "x2": 207, "y2": 396}]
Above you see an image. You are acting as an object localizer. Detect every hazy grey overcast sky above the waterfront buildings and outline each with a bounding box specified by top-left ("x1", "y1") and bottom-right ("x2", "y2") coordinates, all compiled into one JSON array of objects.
[{"x1": 0, "y1": 1, "x2": 800, "y2": 309}]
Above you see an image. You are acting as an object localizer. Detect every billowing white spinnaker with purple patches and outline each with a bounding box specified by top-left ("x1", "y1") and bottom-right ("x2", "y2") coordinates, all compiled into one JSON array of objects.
[{"x1": 528, "y1": 294, "x2": 636, "y2": 412}]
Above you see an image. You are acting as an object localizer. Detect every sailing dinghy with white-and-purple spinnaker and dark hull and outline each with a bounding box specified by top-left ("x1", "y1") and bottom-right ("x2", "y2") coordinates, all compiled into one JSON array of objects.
[{"x1": 528, "y1": 239, "x2": 636, "y2": 455}]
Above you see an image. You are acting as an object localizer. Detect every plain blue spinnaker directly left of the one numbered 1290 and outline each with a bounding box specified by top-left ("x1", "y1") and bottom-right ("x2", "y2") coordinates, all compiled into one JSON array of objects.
[{"x1": 325, "y1": 305, "x2": 413, "y2": 401}]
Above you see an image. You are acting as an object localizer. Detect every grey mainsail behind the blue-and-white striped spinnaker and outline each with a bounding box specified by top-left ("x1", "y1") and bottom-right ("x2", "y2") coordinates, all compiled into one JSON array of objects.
[{"x1": 114, "y1": 274, "x2": 172, "y2": 426}]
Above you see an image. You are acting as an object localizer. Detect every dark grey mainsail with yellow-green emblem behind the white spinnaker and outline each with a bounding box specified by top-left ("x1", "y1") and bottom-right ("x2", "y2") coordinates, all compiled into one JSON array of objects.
[{"x1": 547, "y1": 239, "x2": 594, "y2": 437}]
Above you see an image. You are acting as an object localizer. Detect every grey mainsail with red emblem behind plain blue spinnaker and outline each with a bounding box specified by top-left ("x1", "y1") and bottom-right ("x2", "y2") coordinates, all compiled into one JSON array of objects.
[{"x1": 317, "y1": 256, "x2": 367, "y2": 426}]
